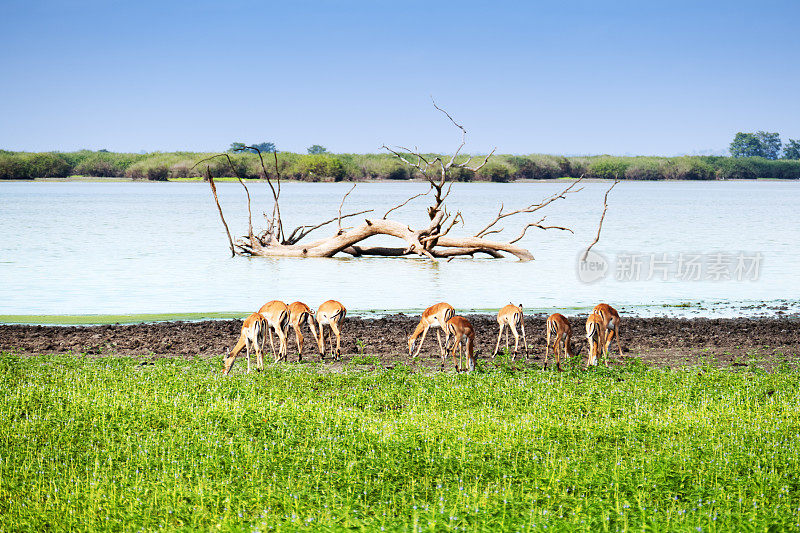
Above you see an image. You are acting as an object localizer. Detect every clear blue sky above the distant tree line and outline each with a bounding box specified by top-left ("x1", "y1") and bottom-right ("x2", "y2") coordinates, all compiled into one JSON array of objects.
[{"x1": 0, "y1": 0, "x2": 800, "y2": 155}]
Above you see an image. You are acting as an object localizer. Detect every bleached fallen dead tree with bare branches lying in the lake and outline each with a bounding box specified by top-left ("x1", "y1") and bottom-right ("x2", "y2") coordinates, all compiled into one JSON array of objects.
[{"x1": 195, "y1": 102, "x2": 583, "y2": 261}]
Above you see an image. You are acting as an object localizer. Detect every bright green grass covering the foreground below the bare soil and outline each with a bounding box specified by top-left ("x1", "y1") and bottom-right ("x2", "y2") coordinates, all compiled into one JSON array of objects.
[{"x1": 0, "y1": 354, "x2": 800, "y2": 531}]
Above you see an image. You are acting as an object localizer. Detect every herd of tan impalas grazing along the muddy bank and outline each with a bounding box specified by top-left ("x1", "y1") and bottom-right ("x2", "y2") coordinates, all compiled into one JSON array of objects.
[{"x1": 222, "y1": 300, "x2": 622, "y2": 375}]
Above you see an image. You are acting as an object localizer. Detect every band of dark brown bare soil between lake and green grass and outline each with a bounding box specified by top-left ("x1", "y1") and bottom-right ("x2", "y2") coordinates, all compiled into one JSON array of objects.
[{"x1": 0, "y1": 315, "x2": 800, "y2": 371}]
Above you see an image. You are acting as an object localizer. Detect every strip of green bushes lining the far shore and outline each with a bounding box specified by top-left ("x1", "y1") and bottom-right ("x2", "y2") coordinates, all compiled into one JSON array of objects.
[{"x1": 0, "y1": 150, "x2": 800, "y2": 182}]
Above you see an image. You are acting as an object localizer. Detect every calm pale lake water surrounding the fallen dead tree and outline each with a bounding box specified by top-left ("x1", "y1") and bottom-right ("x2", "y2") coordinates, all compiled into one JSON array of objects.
[{"x1": 0, "y1": 182, "x2": 800, "y2": 315}]
